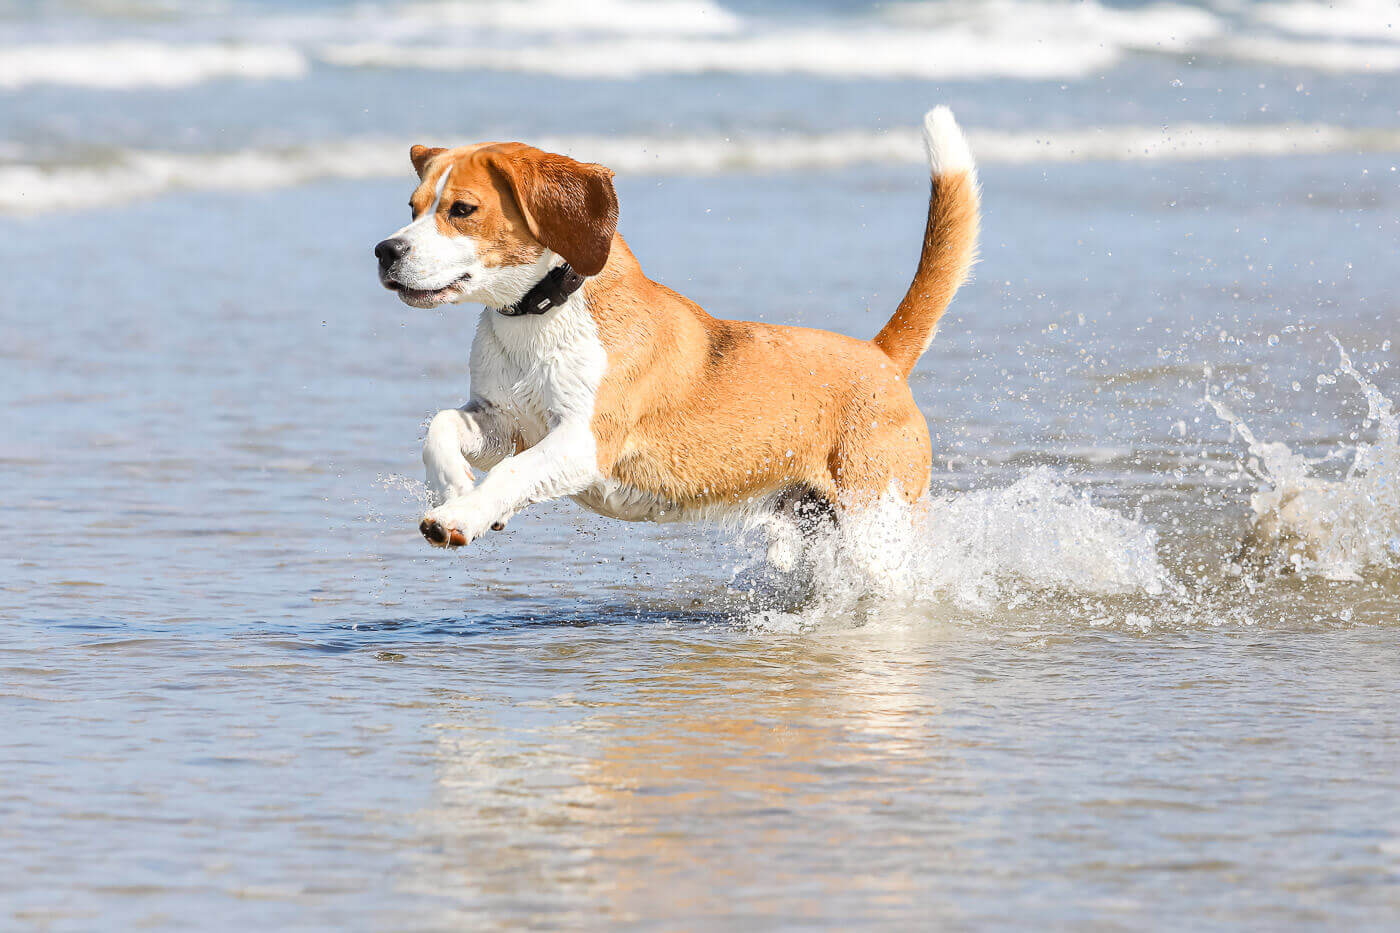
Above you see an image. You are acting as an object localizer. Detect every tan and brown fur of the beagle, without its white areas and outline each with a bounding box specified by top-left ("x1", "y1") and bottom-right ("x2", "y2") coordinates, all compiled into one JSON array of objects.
[{"x1": 412, "y1": 136, "x2": 979, "y2": 509}]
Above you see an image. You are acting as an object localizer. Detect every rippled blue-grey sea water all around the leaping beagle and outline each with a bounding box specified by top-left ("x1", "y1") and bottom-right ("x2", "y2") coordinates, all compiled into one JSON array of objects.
[{"x1": 0, "y1": 3, "x2": 1400, "y2": 929}]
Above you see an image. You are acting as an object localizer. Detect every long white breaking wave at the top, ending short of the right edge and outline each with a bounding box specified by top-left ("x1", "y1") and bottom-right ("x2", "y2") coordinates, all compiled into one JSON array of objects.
[{"x1": 318, "y1": 0, "x2": 1222, "y2": 78}]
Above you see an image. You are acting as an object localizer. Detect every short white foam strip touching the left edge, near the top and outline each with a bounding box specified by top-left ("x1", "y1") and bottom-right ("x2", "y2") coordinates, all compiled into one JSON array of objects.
[{"x1": 0, "y1": 39, "x2": 309, "y2": 90}]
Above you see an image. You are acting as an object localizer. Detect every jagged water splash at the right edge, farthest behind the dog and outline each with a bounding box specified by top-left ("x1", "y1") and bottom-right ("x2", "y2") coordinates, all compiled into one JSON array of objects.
[{"x1": 1205, "y1": 338, "x2": 1400, "y2": 580}]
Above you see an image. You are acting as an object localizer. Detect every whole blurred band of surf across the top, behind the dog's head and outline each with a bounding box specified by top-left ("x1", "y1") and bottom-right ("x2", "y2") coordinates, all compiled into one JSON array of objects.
[{"x1": 0, "y1": 0, "x2": 1400, "y2": 213}]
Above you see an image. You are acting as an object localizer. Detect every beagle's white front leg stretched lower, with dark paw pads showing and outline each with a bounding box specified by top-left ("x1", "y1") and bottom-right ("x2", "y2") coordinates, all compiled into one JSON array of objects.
[{"x1": 419, "y1": 422, "x2": 599, "y2": 548}]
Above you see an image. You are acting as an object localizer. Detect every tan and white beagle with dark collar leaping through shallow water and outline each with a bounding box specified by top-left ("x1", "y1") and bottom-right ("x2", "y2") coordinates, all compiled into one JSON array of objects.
[{"x1": 374, "y1": 106, "x2": 979, "y2": 546}]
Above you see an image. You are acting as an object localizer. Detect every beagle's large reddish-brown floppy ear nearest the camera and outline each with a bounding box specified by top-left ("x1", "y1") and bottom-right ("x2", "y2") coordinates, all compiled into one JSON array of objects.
[{"x1": 486, "y1": 147, "x2": 617, "y2": 276}]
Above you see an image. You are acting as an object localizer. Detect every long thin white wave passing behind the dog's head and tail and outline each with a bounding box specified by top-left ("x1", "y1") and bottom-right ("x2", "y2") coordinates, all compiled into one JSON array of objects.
[{"x1": 0, "y1": 123, "x2": 1400, "y2": 214}]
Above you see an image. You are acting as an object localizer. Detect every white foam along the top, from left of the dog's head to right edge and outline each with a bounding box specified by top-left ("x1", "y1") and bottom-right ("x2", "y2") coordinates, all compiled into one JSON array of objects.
[{"x1": 319, "y1": 0, "x2": 1400, "y2": 80}]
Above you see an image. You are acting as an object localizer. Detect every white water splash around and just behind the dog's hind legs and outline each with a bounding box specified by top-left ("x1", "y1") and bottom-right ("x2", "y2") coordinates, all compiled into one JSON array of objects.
[{"x1": 741, "y1": 468, "x2": 1180, "y2": 630}]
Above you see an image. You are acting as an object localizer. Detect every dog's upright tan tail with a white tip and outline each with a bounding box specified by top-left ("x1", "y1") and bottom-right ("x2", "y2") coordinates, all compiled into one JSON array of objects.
[{"x1": 875, "y1": 106, "x2": 980, "y2": 374}]
